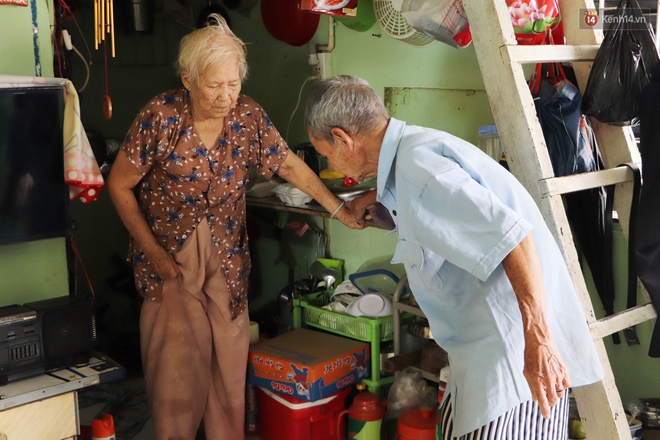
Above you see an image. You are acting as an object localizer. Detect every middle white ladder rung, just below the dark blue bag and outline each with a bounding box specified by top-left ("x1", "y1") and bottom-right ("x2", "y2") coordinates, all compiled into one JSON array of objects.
[{"x1": 539, "y1": 166, "x2": 635, "y2": 197}]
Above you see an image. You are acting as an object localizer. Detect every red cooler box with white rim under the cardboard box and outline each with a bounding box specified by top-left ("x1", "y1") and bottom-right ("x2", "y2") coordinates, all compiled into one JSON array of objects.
[{"x1": 257, "y1": 387, "x2": 351, "y2": 440}]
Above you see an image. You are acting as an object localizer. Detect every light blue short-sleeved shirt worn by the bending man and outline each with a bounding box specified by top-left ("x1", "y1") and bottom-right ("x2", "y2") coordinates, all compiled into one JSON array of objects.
[{"x1": 377, "y1": 118, "x2": 603, "y2": 436}]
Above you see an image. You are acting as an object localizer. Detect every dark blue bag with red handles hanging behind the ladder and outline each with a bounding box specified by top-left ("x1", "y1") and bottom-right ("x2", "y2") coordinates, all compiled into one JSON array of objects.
[{"x1": 530, "y1": 63, "x2": 596, "y2": 177}]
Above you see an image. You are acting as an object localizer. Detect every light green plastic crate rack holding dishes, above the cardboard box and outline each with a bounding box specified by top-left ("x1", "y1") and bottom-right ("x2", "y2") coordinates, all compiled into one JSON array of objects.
[{"x1": 293, "y1": 290, "x2": 414, "y2": 383}]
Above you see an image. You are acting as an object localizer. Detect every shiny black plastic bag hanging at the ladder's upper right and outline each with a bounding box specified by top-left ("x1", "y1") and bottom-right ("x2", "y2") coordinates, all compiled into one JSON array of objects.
[{"x1": 582, "y1": 0, "x2": 658, "y2": 125}]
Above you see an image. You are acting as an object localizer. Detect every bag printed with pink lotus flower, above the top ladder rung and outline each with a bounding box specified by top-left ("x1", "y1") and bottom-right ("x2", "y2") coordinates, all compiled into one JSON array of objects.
[{"x1": 506, "y1": 0, "x2": 563, "y2": 45}]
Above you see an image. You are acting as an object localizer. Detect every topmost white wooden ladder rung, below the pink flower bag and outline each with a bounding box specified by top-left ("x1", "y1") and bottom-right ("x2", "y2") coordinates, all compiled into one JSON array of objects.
[{"x1": 500, "y1": 44, "x2": 600, "y2": 64}]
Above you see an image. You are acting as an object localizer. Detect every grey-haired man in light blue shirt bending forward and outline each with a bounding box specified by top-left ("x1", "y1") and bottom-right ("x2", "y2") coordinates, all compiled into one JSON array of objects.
[{"x1": 305, "y1": 76, "x2": 603, "y2": 440}]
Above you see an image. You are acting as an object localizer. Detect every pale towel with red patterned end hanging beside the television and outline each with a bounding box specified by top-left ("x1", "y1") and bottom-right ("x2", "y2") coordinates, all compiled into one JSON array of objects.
[{"x1": 62, "y1": 80, "x2": 105, "y2": 204}]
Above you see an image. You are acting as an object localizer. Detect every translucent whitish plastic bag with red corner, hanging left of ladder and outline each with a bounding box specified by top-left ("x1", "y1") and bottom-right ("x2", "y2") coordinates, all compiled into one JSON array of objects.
[{"x1": 401, "y1": 0, "x2": 472, "y2": 48}]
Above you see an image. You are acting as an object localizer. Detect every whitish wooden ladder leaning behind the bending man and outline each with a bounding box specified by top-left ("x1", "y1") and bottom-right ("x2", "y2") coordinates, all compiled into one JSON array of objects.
[{"x1": 463, "y1": 0, "x2": 656, "y2": 440}]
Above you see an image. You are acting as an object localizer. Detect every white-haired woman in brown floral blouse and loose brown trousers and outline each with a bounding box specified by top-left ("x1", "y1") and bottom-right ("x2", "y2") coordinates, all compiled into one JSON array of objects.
[{"x1": 107, "y1": 15, "x2": 363, "y2": 440}]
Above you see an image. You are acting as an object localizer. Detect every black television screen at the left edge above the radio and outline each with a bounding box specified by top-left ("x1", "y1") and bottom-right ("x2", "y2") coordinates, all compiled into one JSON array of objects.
[{"x1": 0, "y1": 86, "x2": 70, "y2": 244}]
